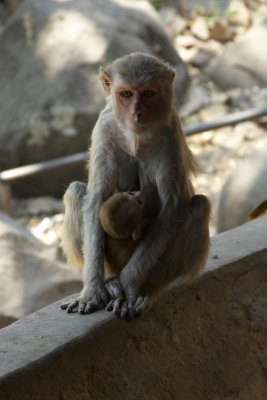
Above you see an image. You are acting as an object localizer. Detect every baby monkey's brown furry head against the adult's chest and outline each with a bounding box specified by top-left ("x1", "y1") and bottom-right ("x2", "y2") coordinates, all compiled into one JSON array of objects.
[{"x1": 99, "y1": 192, "x2": 145, "y2": 240}]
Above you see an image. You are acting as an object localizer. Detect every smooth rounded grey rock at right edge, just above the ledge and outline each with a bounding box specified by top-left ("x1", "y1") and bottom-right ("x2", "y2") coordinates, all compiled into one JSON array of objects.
[{"x1": 215, "y1": 153, "x2": 267, "y2": 232}]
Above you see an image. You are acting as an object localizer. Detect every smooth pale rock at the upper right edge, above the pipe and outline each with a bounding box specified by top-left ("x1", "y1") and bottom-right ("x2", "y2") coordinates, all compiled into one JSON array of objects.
[{"x1": 207, "y1": 21, "x2": 267, "y2": 89}]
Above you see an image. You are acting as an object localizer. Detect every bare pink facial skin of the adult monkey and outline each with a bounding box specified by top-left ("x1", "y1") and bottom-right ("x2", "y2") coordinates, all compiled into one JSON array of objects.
[{"x1": 115, "y1": 83, "x2": 162, "y2": 126}]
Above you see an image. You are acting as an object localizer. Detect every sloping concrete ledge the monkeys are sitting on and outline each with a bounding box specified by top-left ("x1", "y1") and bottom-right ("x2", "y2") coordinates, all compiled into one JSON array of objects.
[{"x1": 0, "y1": 217, "x2": 267, "y2": 400}]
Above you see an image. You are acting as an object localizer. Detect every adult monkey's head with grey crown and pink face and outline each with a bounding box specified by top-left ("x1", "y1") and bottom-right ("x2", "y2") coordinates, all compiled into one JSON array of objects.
[{"x1": 100, "y1": 53, "x2": 175, "y2": 132}]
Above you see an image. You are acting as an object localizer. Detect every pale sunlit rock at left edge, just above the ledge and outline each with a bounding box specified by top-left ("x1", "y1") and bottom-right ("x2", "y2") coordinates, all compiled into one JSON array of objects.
[{"x1": 0, "y1": 213, "x2": 81, "y2": 327}]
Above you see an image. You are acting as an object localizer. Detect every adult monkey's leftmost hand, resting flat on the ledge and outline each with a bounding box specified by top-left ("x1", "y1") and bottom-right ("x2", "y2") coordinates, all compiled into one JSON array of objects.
[{"x1": 61, "y1": 284, "x2": 109, "y2": 314}]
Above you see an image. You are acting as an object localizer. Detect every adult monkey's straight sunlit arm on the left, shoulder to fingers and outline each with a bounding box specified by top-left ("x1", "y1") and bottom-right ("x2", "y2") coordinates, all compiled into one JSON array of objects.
[{"x1": 63, "y1": 125, "x2": 118, "y2": 314}]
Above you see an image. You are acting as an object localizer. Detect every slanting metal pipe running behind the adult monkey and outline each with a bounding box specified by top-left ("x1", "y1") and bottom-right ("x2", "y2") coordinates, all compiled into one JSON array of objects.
[{"x1": 0, "y1": 107, "x2": 267, "y2": 184}]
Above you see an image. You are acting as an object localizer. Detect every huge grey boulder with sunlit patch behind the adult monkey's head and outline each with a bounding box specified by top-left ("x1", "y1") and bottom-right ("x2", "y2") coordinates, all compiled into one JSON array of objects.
[{"x1": 0, "y1": 0, "x2": 191, "y2": 194}]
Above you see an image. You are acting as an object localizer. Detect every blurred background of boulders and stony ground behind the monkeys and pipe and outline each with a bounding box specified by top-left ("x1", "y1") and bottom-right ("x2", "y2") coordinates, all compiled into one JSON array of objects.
[{"x1": 0, "y1": 0, "x2": 267, "y2": 326}]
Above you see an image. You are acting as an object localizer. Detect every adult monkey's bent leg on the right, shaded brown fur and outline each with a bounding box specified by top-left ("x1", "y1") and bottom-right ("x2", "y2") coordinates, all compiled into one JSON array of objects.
[{"x1": 115, "y1": 195, "x2": 213, "y2": 319}]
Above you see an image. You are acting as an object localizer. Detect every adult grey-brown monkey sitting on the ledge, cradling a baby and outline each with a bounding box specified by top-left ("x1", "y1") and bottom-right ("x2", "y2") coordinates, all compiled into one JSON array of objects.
[{"x1": 62, "y1": 53, "x2": 210, "y2": 318}]
